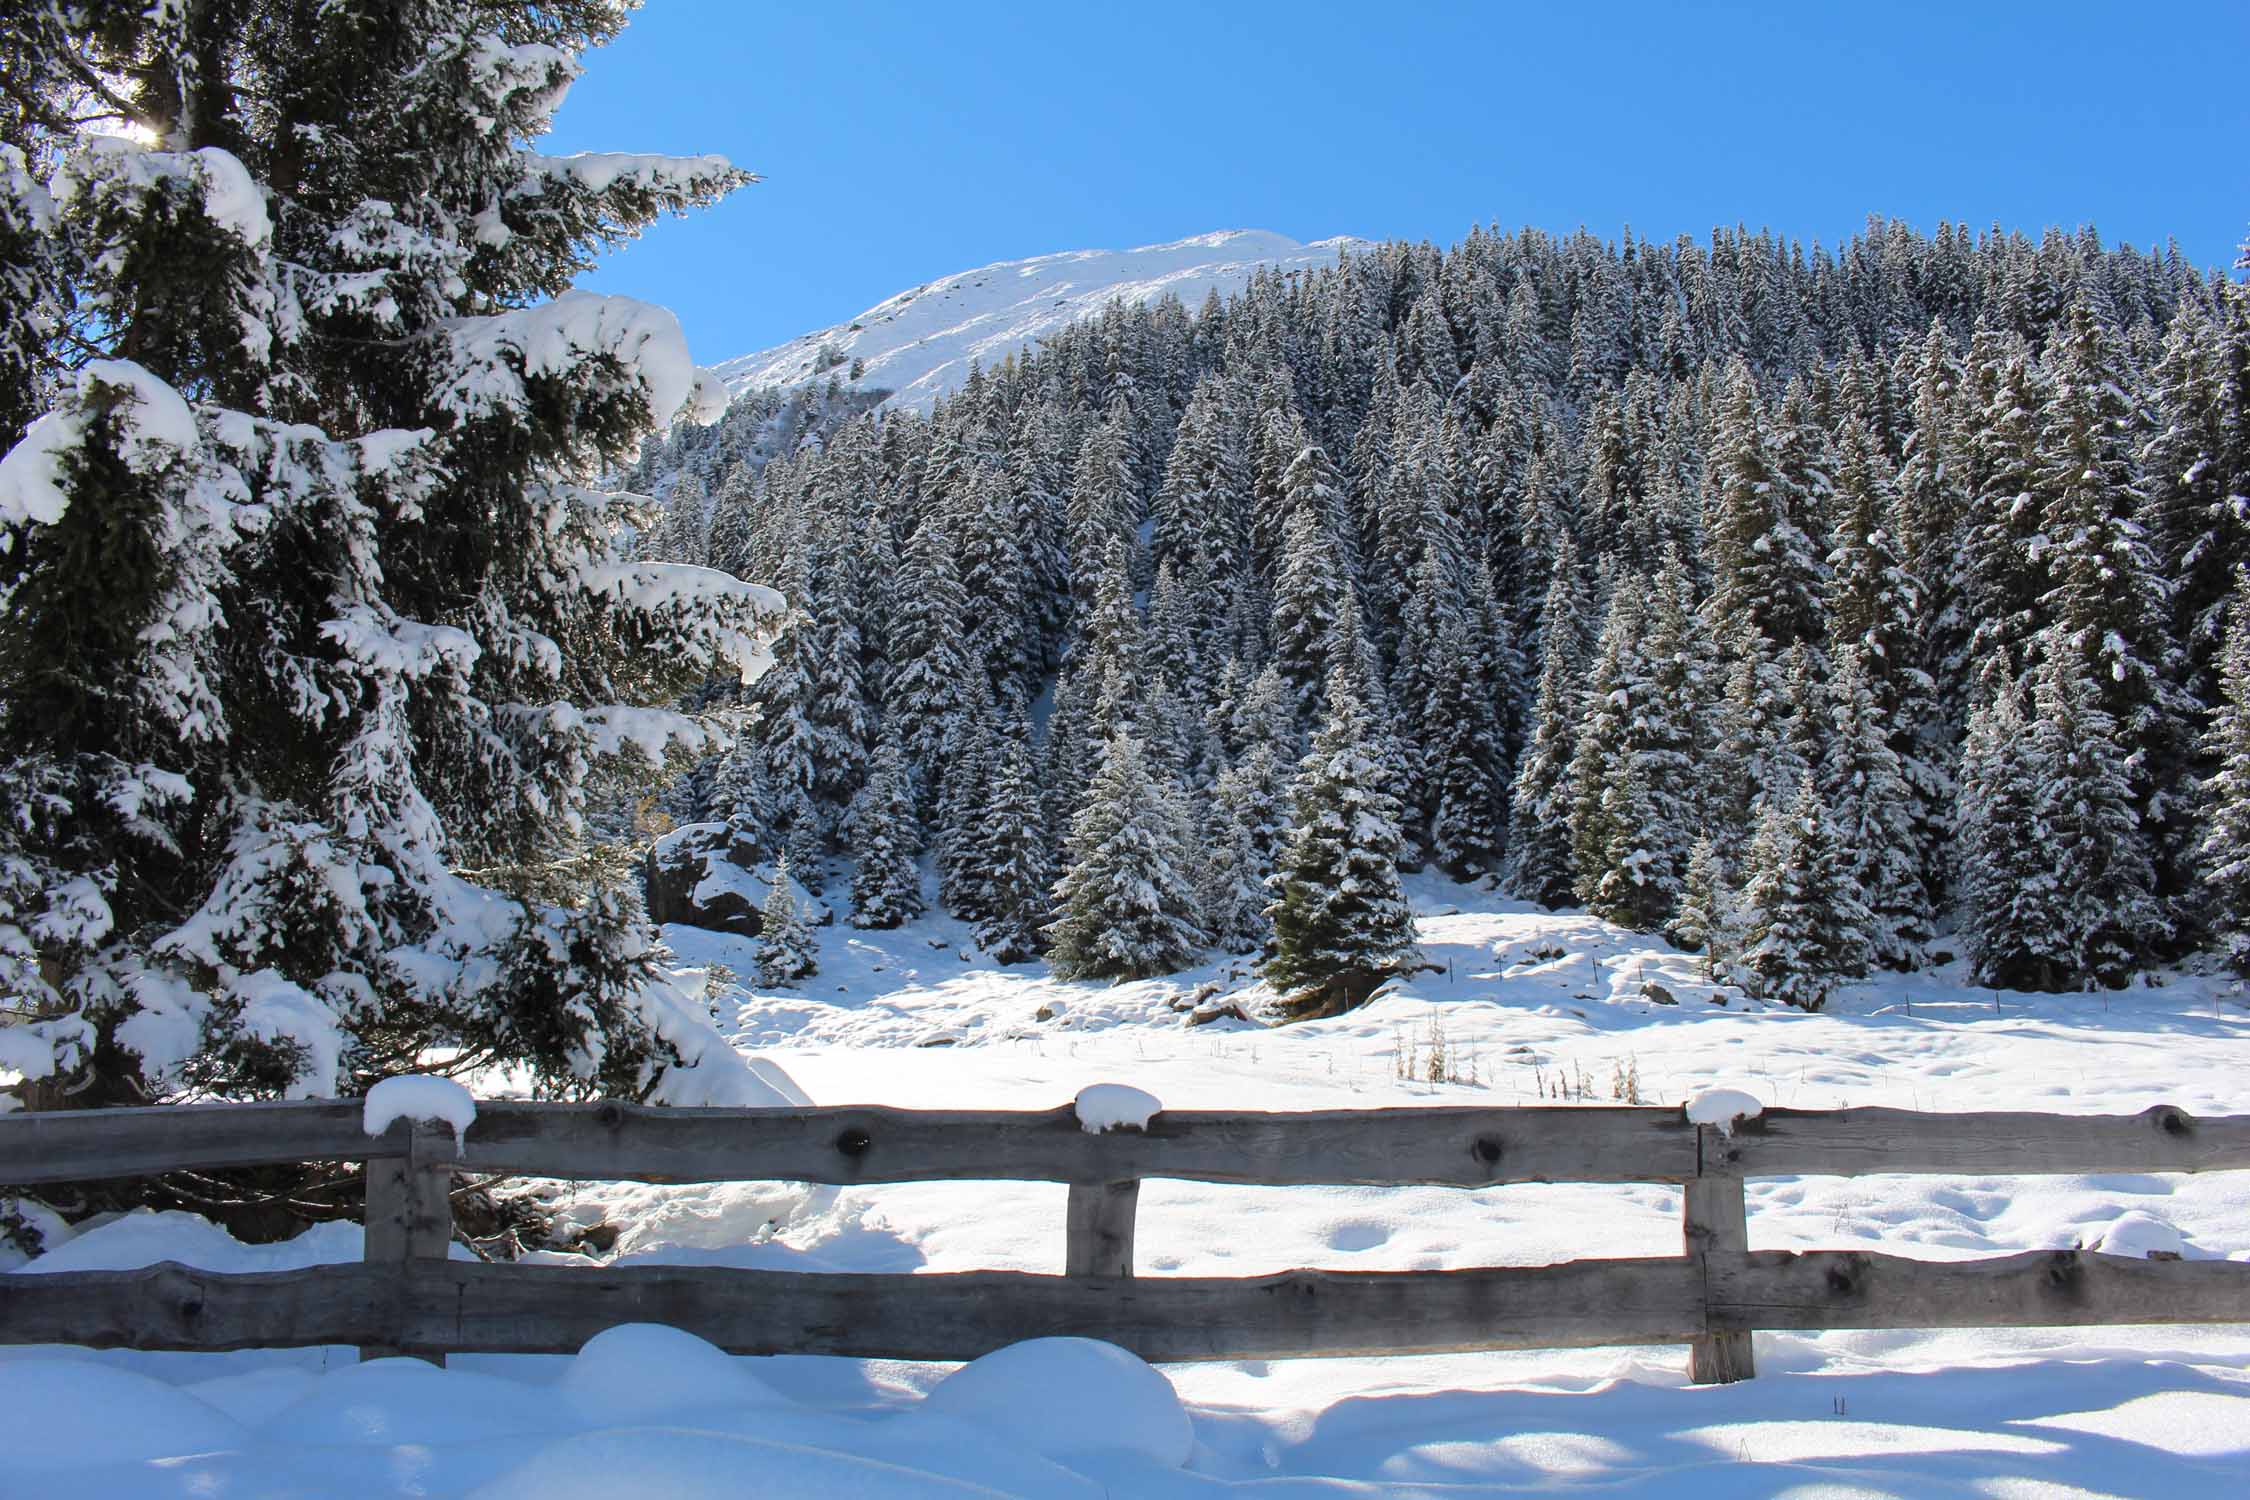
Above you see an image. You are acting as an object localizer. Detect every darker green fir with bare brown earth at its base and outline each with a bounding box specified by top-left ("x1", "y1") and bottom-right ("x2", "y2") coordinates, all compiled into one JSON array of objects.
[{"x1": 1260, "y1": 670, "x2": 1420, "y2": 1016}]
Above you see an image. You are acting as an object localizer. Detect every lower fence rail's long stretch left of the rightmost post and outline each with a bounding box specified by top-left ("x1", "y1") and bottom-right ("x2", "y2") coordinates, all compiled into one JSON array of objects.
[{"x1": 0, "y1": 1259, "x2": 1703, "y2": 1361}]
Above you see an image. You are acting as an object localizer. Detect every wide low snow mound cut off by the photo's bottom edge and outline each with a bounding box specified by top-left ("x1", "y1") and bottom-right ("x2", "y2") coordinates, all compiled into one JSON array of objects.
[{"x1": 468, "y1": 1428, "x2": 1010, "y2": 1500}]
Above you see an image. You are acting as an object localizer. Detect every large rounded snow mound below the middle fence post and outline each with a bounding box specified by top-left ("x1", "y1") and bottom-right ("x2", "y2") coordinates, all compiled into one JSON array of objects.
[{"x1": 923, "y1": 1338, "x2": 1195, "y2": 1469}]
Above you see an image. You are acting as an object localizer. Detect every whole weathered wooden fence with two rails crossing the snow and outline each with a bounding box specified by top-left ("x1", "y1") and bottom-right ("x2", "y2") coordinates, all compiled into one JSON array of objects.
[{"x1": 0, "y1": 1102, "x2": 2250, "y2": 1381}]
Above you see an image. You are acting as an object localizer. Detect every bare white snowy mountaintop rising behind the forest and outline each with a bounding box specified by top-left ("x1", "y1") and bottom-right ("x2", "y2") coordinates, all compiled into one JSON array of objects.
[{"x1": 718, "y1": 229, "x2": 1368, "y2": 412}]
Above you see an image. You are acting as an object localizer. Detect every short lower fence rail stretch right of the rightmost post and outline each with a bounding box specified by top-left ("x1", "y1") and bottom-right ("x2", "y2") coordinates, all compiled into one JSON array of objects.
[{"x1": 1706, "y1": 1250, "x2": 2250, "y2": 1329}]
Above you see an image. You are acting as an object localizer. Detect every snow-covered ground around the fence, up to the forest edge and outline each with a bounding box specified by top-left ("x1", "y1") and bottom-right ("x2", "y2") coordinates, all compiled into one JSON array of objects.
[{"x1": 0, "y1": 879, "x2": 2250, "y2": 1500}]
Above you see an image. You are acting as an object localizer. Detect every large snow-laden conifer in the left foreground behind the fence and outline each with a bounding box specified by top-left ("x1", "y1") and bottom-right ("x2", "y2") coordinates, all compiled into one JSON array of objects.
[{"x1": 0, "y1": 0, "x2": 776, "y2": 1104}]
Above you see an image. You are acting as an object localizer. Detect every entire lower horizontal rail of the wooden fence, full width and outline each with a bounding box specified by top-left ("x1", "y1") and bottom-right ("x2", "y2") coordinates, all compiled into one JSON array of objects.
[{"x1": 0, "y1": 1250, "x2": 2250, "y2": 1363}]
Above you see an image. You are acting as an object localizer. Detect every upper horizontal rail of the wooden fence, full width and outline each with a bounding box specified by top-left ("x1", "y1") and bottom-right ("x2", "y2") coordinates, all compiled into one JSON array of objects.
[{"x1": 0, "y1": 1102, "x2": 2250, "y2": 1187}]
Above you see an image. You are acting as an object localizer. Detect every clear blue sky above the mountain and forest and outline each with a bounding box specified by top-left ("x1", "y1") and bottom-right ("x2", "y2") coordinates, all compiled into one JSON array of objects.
[{"x1": 549, "y1": 0, "x2": 2250, "y2": 360}]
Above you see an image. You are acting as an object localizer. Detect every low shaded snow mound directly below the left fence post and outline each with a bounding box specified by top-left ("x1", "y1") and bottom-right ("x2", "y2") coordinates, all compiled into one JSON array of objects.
[{"x1": 257, "y1": 1358, "x2": 569, "y2": 1453}]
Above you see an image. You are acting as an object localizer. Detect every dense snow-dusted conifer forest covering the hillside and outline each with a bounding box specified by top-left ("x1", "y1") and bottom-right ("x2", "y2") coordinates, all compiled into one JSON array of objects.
[{"x1": 641, "y1": 223, "x2": 2250, "y2": 1005}]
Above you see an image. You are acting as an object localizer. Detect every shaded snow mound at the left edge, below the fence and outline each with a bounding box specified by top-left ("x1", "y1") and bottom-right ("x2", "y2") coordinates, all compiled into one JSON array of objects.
[{"x1": 0, "y1": 1358, "x2": 248, "y2": 1493}]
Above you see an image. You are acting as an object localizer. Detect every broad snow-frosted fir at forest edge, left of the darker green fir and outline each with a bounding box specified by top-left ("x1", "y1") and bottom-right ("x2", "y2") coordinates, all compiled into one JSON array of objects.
[{"x1": 1046, "y1": 733, "x2": 1202, "y2": 978}]
